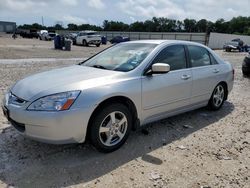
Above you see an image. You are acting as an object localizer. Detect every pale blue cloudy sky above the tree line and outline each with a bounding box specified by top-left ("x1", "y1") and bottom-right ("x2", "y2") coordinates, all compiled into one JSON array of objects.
[{"x1": 0, "y1": 0, "x2": 250, "y2": 27}]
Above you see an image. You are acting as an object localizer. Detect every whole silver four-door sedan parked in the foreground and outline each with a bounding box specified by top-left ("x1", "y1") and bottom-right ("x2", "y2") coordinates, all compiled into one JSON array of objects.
[{"x1": 2, "y1": 40, "x2": 234, "y2": 152}]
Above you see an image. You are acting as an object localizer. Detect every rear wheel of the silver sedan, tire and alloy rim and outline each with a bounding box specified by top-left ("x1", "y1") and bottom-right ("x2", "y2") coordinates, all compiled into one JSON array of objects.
[{"x1": 208, "y1": 83, "x2": 227, "y2": 111}]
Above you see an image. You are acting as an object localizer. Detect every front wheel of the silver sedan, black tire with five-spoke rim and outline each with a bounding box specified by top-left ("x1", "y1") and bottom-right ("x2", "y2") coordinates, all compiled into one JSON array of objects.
[{"x1": 89, "y1": 103, "x2": 132, "y2": 153}]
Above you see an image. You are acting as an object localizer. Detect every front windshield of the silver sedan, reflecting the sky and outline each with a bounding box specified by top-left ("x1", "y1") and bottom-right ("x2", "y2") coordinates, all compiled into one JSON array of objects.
[{"x1": 82, "y1": 43, "x2": 156, "y2": 72}]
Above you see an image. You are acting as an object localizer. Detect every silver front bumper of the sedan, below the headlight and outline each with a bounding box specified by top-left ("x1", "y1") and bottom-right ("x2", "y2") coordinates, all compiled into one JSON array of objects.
[{"x1": 2, "y1": 104, "x2": 90, "y2": 144}]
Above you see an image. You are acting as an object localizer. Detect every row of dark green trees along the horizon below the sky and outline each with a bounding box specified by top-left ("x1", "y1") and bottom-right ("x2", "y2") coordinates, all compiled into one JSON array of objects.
[{"x1": 18, "y1": 16, "x2": 250, "y2": 35}]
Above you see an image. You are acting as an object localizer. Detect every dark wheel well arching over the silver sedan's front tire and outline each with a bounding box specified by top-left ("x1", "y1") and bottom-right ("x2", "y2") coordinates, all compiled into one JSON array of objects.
[{"x1": 87, "y1": 96, "x2": 139, "y2": 139}]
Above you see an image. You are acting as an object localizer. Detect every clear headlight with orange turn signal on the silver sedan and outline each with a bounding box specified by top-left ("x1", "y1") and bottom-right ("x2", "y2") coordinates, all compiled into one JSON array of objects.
[{"x1": 27, "y1": 91, "x2": 80, "y2": 111}]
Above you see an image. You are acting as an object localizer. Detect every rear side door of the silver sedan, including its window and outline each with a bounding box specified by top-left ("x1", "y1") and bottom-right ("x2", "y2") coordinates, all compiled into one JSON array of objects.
[{"x1": 187, "y1": 45, "x2": 220, "y2": 104}]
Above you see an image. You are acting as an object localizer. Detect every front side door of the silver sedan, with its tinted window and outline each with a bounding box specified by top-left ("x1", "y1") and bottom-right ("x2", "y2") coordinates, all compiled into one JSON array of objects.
[{"x1": 142, "y1": 45, "x2": 192, "y2": 122}]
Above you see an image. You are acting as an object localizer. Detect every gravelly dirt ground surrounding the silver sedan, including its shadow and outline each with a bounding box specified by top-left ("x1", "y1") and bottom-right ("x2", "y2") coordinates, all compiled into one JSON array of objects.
[{"x1": 0, "y1": 37, "x2": 250, "y2": 188}]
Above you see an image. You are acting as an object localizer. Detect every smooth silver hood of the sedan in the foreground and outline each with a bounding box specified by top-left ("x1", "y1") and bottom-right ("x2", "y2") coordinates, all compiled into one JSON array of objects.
[{"x1": 11, "y1": 65, "x2": 124, "y2": 101}]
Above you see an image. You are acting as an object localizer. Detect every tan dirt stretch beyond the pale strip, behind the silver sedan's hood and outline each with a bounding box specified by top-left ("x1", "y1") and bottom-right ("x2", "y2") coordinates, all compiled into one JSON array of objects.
[{"x1": 0, "y1": 35, "x2": 108, "y2": 59}]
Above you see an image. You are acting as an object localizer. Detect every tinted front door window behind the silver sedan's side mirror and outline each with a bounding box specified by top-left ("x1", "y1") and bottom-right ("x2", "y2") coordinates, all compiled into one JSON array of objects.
[{"x1": 153, "y1": 45, "x2": 186, "y2": 71}]
